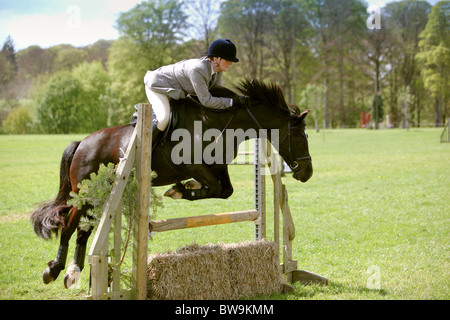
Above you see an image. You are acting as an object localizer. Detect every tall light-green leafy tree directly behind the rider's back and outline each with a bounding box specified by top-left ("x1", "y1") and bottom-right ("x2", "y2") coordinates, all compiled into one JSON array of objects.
[{"x1": 108, "y1": 0, "x2": 187, "y2": 121}]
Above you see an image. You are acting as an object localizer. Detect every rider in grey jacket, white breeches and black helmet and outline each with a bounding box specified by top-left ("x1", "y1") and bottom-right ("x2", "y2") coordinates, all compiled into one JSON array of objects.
[{"x1": 144, "y1": 39, "x2": 239, "y2": 145}]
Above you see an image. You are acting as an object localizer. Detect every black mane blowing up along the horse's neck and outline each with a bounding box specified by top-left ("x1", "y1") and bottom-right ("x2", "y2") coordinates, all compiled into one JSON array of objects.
[{"x1": 234, "y1": 78, "x2": 292, "y2": 114}]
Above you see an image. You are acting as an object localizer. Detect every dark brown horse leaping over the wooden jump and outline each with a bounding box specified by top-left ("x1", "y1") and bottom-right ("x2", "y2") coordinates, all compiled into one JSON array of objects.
[{"x1": 31, "y1": 79, "x2": 313, "y2": 288}]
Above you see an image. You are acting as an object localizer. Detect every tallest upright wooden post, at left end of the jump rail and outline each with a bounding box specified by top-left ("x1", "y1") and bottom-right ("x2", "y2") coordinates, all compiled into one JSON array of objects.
[{"x1": 131, "y1": 104, "x2": 152, "y2": 300}]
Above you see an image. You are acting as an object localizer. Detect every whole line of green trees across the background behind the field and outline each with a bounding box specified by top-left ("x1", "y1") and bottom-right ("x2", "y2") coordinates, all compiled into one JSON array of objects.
[{"x1": 0, "y1": 0, "x2": 450, "y2": 133}]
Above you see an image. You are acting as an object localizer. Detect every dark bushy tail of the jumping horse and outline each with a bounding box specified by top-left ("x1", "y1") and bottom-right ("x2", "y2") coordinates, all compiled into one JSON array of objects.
[{"x1": 31, "y1": 141, "x2": 81, "y2": 239}]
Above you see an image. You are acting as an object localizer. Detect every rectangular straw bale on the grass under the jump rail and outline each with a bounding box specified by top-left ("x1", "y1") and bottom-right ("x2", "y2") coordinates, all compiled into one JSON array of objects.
[{"x1": 148, "y1": 240, "x2": 285, "y2": 300}]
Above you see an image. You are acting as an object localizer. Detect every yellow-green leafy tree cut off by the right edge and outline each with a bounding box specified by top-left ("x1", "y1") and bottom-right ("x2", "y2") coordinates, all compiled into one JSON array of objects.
[{"x1": 416, "y1": 1, "x2": 450, "y2": 126}]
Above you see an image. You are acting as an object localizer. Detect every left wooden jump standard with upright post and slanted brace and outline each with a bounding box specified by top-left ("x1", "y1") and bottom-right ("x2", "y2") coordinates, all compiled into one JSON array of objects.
[{"x1": 88, "y1": 104, "x2": 152, "y2": 299}]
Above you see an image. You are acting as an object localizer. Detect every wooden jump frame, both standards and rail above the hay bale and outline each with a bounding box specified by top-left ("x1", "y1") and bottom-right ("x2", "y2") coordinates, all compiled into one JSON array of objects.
[{"x1": 87, "y1": 104, "x2": 328, "y2": 300}]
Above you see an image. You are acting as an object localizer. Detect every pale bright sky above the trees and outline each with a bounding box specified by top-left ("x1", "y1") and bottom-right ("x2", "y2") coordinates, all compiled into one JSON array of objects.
[{"x1": 0, "y1": 0, "x2": 438, "y2": 51}]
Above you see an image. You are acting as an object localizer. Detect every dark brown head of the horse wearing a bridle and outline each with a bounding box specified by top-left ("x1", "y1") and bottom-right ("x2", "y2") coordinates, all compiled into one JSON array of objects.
[{"x1": 279, "y1": 110, "x2": 313, "y2": 182}]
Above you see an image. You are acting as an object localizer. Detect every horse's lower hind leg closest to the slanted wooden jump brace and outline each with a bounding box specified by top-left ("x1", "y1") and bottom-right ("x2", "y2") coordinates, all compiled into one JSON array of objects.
[{"x1": 64, "y1": 228, "x2": 92, "y2": 289}]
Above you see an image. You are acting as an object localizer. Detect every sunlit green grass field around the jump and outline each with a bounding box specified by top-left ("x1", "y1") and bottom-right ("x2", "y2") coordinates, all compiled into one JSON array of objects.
[{"x1": 0, "y1": 129, "x2": 450, "y2": 300}]
